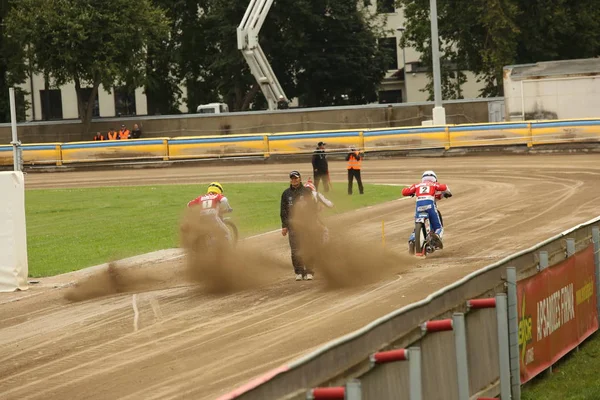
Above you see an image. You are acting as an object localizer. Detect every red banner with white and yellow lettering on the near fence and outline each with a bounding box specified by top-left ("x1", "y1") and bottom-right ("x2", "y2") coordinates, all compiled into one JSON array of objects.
[{"x1": 517, "y1": 245, "x2": 598, "y2": 383}]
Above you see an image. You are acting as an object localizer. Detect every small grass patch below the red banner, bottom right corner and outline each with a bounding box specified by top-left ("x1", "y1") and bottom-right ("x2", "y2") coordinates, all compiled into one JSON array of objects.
[{"x1": 521, "y1": 333, "x2": 600, "y2": 400}]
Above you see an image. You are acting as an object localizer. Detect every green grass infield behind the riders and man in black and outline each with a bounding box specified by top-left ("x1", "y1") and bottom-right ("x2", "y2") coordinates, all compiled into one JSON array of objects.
[{"x1": 25, "y1": 183, "x2": 402, "y2": 277}]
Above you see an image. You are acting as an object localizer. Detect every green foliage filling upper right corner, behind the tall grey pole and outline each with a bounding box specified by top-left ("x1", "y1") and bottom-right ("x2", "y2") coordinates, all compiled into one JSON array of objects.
[{"x1": 396, "y1": 0, "x2": 600, "y2": 100}]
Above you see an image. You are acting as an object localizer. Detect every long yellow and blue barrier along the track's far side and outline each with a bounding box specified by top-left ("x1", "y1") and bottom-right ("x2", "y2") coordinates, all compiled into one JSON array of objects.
[{"x1": 0, "y1": 119, "x2": 600, "y2": 166}]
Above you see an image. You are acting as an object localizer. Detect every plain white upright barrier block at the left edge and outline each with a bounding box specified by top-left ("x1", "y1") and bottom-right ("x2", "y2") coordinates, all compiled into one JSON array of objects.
[{"x1": 0, "y1": 171, "x2": 28, "y2": 292}]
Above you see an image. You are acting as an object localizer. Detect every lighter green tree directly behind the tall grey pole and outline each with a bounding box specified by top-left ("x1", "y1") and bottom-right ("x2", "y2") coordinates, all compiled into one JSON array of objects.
[{"x1": 397, "y1": 0, "x2": 519, "y2": 100}]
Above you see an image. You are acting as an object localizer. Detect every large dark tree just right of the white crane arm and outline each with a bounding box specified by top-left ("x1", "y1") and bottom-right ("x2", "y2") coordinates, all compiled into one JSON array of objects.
[{"x1": 291, "y1": 0, "x2": 393, "y2": 107}]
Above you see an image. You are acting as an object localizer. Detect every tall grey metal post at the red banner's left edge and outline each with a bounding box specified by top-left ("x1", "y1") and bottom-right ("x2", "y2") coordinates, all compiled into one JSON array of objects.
[{"x1": 506, "y1": 267, "x2": 521, "y2": 400}]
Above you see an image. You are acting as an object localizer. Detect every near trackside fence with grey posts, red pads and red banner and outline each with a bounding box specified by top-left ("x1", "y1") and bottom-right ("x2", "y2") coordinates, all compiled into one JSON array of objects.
[{"x1": 219, "y1": 217, "x2": 600, "y2": 400}]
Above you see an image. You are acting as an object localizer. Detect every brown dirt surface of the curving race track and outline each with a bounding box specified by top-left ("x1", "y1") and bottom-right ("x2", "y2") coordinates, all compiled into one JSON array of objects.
[{"x1": 0, "y1": 155, "x2": 600, "y2": 400}]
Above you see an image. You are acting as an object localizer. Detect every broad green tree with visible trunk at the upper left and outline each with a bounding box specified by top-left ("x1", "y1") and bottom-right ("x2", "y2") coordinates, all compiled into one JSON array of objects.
[{"x1": 6, "y1": 0, "x2": 168, "y2": 133}]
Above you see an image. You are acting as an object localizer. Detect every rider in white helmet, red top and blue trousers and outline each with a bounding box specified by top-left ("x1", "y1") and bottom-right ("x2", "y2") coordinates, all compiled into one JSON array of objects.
[{"x1": 402, "y1": 171, "x2": 452, "y2": 249}]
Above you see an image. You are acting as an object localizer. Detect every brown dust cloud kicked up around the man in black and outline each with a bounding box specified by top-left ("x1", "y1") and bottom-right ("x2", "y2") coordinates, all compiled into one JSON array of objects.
[{"x1": 64, "y1": 207, "x2": 415, "y2": 302}]
